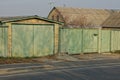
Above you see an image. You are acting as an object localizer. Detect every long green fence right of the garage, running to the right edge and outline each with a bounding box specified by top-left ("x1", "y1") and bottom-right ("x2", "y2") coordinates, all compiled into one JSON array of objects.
[{"x1": 59, "y1": 28, "x2": 120, "y2": 54}]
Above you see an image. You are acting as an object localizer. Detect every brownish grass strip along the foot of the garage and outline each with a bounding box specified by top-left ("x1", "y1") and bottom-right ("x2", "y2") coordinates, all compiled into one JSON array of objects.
[{"x1": 0, "y1": 55, "x2": 56, "y2": 64}]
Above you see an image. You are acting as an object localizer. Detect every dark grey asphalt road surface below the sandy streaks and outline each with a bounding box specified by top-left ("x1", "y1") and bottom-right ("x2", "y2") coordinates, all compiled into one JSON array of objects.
[{"x1": 0, "y1": 65, "x2": 120, "y2": 80}]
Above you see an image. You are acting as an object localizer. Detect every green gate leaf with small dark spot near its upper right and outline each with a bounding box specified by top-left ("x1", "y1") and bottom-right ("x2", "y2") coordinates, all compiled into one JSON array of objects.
[{"x1": 82, "y1": 29, "x2": 98, "y2": 53}]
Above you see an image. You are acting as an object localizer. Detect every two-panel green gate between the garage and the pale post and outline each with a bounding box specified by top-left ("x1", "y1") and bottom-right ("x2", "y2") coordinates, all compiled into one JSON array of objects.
[{"x1": 60, "y1": 28, "x2": 98, "y2": 54}]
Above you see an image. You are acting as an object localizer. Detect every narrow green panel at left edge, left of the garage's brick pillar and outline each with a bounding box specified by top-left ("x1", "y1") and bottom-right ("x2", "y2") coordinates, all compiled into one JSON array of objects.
[{"x1": 0, "y1": 26, "x2": 8, "y2": 57}]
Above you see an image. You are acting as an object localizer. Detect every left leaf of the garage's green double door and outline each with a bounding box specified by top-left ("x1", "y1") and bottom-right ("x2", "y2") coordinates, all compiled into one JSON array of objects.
[{"x1": 12, "y1": 24, "x2": 34, "y2": 57}]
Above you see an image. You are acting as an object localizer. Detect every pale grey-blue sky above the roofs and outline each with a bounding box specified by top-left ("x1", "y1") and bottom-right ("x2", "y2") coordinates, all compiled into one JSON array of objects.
[{"x1": 0, "y1": 0, "x2": 120, "y2": 17}]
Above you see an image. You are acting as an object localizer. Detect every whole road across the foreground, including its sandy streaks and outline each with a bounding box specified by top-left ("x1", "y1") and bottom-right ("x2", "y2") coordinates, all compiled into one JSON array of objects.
[{"x1": 0, "y1": 59, "x2": 120, "y2": 80}]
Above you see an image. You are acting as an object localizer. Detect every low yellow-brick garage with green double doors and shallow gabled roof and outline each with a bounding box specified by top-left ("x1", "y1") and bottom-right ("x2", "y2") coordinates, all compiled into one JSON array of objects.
[{"x1": 0, "y1": 15, "x2": 61, "y2": 57}]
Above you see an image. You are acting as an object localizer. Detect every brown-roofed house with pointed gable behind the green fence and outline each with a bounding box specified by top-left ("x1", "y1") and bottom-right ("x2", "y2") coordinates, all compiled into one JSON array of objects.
[{"x1": 48, "y1": 7, "x2": 115, "y2": 28}]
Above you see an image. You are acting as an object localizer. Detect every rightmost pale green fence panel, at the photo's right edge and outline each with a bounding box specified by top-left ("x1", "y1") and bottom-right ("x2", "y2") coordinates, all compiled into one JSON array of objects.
[{"x1": 111, "y1": 29, "x2": 120, "y2": 52}]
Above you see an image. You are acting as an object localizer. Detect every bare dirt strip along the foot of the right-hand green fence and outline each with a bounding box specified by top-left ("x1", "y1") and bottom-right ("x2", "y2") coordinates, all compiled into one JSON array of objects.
[{"x1": 55, "y1": 53, "x2": 120, "y2": 61}]
